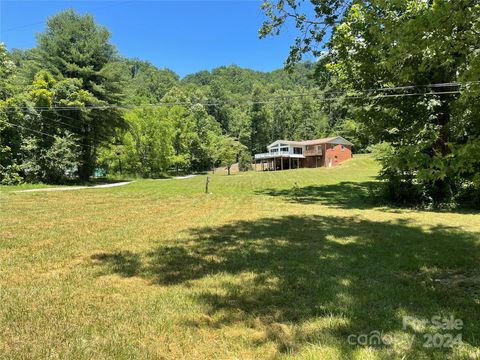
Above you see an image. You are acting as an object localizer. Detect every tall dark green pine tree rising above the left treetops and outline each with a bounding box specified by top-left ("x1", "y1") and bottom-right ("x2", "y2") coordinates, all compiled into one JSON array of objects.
[{"x1": 38, "y1": 10, "x2": 123, "y2": 180}]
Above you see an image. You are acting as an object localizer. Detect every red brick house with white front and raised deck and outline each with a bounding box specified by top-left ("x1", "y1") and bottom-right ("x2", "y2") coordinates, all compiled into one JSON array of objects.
[{"x1": 255, "y1": 136, "x2": 353, "y2": 170}]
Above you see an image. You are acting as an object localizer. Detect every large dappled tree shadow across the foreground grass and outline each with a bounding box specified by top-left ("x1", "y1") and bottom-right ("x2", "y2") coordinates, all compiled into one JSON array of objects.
[{"x1": 93, "y1": 215, "x2": 480, "y2": 358}]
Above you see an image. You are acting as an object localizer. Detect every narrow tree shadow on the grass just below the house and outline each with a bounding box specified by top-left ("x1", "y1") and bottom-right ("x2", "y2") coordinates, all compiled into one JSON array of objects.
[{"x1": 256, "y1": 181, "x2": 384, "y2": 209}]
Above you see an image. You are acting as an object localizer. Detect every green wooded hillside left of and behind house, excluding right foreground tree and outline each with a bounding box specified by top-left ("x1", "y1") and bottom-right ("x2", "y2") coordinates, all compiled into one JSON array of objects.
[{"x1": 0, "y1": 10, "x2": 351, "y2": 184}]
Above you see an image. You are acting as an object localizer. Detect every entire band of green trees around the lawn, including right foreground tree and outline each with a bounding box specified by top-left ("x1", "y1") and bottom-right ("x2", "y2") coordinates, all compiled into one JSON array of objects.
[{"x1": 0, "y1": 0, "x2": 480, "y2": 205}]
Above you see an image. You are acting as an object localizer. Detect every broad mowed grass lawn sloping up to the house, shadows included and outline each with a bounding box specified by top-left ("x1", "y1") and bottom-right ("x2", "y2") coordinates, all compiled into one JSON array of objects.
[{"x1": 0, "y1": 158, "x2": 480, "y2": 359}]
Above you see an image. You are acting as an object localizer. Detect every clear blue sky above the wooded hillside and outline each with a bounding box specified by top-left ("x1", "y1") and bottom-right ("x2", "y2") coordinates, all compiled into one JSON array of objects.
[{"x1": 0, "y1": 0, "x2": 308, "y2": 77}]
